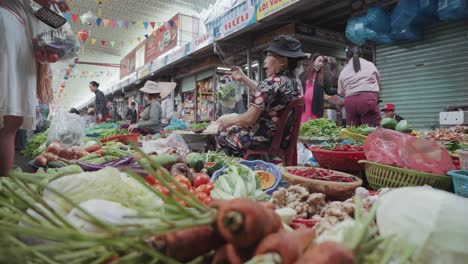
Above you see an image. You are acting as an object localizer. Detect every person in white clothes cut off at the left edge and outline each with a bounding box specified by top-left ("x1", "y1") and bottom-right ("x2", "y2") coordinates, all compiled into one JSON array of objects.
[{"x1": 0, "y1": 0, "x2": 68, "y2": 176}]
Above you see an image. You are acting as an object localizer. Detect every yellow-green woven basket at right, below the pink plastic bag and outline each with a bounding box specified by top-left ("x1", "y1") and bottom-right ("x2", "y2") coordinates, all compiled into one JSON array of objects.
[{"x1": 359, "y1": 160, "x2": 452, "y2": 191}]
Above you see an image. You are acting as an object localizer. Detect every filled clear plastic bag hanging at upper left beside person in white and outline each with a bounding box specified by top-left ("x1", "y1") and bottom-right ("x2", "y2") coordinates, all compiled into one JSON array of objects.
[{"x1": 35, "y1": 23, "x2": 81, "y2": 63}]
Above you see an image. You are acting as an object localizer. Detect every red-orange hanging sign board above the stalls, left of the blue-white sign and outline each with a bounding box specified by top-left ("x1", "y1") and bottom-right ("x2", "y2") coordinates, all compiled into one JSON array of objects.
[{"x1": 145, "y1": 14, "x2": 180, "y2": 63}]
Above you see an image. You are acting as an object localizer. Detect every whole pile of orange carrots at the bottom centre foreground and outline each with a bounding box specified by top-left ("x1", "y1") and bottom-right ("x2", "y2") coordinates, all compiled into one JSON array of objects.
[{"x1": 150, "y1": 198, "x2": 356, "y2": 264}]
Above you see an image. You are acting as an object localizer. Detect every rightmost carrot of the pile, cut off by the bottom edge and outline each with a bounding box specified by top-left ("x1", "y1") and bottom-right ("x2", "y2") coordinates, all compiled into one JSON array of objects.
[{"x1": 296, "y1": 242, "x2": 357, "y2": 264}]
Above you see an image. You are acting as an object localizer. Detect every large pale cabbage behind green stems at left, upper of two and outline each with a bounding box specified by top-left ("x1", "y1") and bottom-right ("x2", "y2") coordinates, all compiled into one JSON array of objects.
[{"x1": 43, "y1": 167, "x2": 162, "y2": 213}]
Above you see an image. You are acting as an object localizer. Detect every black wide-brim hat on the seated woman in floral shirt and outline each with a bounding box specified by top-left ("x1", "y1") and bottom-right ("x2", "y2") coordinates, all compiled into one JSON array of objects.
[{"x1": 263, "y1": 35, "x2": 307, "y2": 59}]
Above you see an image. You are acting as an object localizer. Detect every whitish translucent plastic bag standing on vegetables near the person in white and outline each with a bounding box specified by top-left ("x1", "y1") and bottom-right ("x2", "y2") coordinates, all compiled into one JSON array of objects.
[{"x1": 47, "y1": 112, "x2": 86, "y2": 147}]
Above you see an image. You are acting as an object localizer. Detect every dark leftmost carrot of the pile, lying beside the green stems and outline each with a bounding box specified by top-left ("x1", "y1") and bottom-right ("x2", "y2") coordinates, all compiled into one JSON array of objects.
[{"x1": 151, "y1": 226, "x2": 224, "y2": 262}]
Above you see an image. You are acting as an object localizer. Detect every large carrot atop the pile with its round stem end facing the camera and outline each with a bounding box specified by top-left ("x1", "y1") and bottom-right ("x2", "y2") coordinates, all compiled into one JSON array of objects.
[{"x1": 212, "y1": 198, "x2": 282, "y2": 248}]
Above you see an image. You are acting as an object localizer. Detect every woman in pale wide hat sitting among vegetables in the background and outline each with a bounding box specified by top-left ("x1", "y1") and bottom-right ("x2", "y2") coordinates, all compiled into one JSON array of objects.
[{"x1": 121, "y1": 81, "x2": 176, "y2": 135}]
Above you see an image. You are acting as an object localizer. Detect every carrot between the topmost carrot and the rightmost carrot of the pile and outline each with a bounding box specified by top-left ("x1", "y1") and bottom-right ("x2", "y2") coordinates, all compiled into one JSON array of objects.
[{"x1": 254, "y1": 228, "x2": 316, "y2": 263}]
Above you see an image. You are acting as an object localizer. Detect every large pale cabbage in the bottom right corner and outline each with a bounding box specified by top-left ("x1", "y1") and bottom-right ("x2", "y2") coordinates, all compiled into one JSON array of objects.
[{"x1": 377, "y1": 187, "x2": 468, "y2": 264}]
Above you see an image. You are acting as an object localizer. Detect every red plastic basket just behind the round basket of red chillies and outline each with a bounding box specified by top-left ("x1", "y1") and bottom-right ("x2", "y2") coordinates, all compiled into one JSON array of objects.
[{"x1": 309, "y1": 147, "x2": 366, "y2": 171}]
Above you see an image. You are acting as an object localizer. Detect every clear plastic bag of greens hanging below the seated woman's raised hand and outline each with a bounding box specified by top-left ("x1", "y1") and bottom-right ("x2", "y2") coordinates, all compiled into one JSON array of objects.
[{"x1": 216, "y1": 76, "x2": 243, "y2": 109}]
